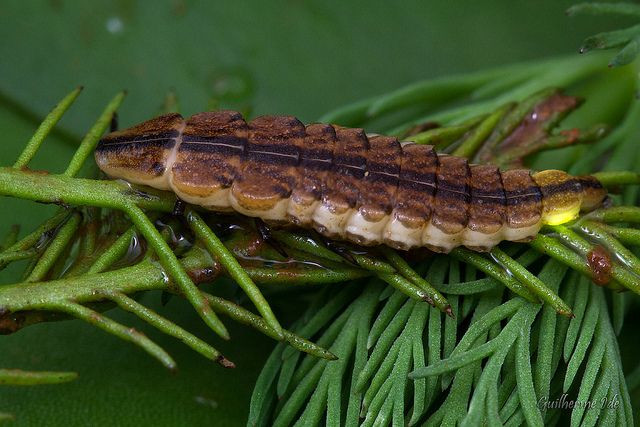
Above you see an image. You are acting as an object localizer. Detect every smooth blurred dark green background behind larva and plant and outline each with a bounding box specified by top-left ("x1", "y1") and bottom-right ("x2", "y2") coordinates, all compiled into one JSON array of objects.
[{"x1": 0, "y1": 0, "x2": 625, "y2": 425}]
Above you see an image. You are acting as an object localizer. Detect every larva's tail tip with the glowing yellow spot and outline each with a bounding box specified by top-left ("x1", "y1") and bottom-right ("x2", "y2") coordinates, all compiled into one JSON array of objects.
[{"x1": 532, "y1": 170, "x2": 606, "y2": 225}]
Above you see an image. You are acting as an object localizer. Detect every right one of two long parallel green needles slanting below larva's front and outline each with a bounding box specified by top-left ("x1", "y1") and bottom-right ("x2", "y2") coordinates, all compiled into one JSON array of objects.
[{"x1": 186, "y1": 209, "x2": 284, "y2": 340}]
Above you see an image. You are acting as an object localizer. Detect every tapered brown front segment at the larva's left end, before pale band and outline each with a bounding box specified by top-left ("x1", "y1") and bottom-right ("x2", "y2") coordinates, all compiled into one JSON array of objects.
[{"x1": 95, "y1": 114, "x2": 184, "y2": 190}]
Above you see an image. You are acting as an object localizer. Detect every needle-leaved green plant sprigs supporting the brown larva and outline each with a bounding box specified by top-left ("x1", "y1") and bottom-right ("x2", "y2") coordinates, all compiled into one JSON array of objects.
[{"x1": 0, "y1": 31, "x2": 640, "y2": 425}]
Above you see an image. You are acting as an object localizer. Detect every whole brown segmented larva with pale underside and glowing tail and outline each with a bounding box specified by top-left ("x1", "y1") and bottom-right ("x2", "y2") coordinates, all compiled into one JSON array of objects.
[{"x1": 96, "y1": 111, "x2": 606, "y2": 252}]
